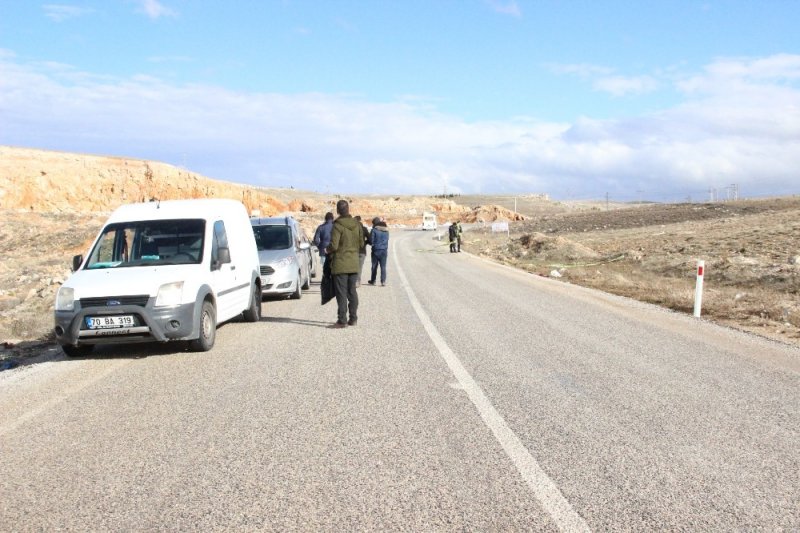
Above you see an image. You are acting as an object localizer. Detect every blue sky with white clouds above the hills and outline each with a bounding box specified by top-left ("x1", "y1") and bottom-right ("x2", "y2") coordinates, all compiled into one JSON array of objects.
[{"x1": 0, "y1": 0, "x2": 800, "y2": 202}]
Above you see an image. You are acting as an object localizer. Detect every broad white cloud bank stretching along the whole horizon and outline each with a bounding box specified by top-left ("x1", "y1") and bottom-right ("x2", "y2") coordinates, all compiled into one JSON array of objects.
[{"x1": 0, "y1": 54, "x2": 800, "y2": 200}]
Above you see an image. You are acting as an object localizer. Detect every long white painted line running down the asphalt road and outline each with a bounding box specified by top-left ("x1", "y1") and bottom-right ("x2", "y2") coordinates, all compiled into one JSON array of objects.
[{"x1": 392, "y1": 235, "x2": 591, "y2": 531}]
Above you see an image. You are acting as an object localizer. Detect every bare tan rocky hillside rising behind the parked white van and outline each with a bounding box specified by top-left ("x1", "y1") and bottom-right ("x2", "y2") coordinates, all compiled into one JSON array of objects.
[{"x1": 0, "y1": 146, "x2": 494, "y2": 225}]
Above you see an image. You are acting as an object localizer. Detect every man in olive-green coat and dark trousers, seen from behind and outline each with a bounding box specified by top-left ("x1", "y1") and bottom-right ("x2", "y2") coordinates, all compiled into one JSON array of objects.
[{"x1": 327, "y1": 200, "x2": 364, "y2": 328}]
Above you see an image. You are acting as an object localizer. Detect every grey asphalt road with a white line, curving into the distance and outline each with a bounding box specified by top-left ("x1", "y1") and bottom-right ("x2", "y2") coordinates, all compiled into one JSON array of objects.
[{"x1": 0, "y1": 230, "x2": 800, "y2": 531}]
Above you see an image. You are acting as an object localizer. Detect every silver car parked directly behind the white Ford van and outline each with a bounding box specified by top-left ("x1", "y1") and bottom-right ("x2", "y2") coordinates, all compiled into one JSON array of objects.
[{"x1": 250, "y1": 217, "x2": 316, "y2": 299}]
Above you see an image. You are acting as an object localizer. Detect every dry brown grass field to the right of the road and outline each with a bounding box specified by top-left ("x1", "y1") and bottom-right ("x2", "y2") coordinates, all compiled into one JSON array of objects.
[{"x1": 466, "y1": 197, "x2": 800, "y2": 346}]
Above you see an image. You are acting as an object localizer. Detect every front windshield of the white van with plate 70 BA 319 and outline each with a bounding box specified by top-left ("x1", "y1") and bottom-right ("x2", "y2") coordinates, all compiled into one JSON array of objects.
[{"x1": 86, "y1": 219, "x2": 205, "y2": 269}]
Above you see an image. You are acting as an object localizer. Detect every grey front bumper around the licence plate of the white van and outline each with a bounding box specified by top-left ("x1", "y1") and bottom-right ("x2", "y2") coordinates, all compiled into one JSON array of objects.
[{"x1": 55, "y1": 298, "x2": 195, "y2": 346}]
